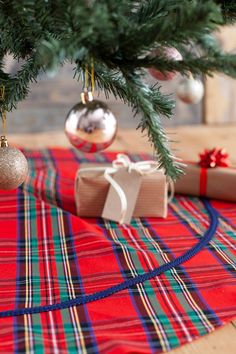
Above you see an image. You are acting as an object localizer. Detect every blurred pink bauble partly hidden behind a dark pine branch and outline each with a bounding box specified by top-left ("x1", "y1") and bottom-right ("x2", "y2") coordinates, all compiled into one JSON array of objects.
[{"x1": 149, "y1": 47, "x2": 183, "y2": 81}]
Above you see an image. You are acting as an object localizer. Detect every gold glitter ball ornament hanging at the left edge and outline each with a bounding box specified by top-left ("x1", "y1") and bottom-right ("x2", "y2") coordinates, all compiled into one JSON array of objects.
[{"x1": 0, "y1": 136, "x2": 28, "y2": 190}]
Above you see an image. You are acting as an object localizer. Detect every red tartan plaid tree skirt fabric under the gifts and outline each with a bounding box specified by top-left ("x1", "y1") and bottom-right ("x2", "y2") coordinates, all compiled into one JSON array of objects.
[{"x1": 0, "y1": 149, "x2": 236, "y2": 354}]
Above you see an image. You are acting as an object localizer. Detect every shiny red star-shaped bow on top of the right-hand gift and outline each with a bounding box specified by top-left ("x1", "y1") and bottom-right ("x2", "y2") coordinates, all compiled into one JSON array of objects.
[{"x1": 199, "y1": 148, "x2": 229, "y2": 168}]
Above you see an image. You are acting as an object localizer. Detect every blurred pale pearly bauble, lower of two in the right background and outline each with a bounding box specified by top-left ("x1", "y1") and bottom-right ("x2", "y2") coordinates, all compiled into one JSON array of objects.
[{"x1": 177, "y1": 76, "x2": 204, "y2": 104}]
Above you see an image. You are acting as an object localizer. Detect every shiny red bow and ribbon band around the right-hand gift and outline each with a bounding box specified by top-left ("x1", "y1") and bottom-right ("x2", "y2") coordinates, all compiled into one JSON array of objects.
[{"x1": 199, "y1": 148, "x2": 230, "y2": 197}]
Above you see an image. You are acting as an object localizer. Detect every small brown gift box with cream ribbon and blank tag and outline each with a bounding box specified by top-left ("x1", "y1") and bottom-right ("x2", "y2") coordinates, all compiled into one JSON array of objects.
[{"x1": 75, "y1": 154, "x2": 168, "y2": 224}]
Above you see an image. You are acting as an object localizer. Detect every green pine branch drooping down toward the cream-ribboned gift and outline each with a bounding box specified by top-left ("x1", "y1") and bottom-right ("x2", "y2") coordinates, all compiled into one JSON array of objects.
[{"x1": 87, "y1": 65, "x2": 184, "y2": 180}]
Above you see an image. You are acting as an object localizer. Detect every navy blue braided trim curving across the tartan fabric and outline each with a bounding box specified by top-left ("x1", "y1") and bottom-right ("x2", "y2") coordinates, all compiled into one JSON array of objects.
[{"x1": 0, "y1": 199, "x2": 218, "y2": 318}]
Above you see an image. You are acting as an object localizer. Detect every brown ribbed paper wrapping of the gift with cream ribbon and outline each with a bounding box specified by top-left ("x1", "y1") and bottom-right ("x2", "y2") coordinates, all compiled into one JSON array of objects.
[{"x1": 75, "y1": 164, "x2": 168, "y2": 218}]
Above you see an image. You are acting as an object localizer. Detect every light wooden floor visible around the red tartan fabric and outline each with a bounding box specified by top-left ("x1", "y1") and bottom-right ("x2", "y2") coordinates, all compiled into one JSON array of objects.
[{"x1": 9, "y1": 126, "x2": 236, "y2": 354}]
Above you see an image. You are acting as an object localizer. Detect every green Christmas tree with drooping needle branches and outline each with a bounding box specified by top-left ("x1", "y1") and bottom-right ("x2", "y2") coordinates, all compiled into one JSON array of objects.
[{"x1": 0, "y1": 0, "x2": 236, "y2": 179}]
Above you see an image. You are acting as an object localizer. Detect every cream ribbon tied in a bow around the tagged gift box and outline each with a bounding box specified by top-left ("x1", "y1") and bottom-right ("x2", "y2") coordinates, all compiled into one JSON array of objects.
[{"x1": 76, "y1": 154, "x2": 174, "y2": 224}]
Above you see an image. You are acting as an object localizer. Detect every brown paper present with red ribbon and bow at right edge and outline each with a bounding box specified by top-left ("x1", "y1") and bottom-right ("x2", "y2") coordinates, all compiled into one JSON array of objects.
[{"x1": 175, "y1": 148, "x2": 236, "y2": 202}]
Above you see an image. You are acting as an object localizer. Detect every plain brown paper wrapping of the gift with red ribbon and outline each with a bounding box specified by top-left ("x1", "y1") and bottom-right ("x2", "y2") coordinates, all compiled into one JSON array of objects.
[{"x1": 175, "y1": 163, "x2": 236, "y2": 202}]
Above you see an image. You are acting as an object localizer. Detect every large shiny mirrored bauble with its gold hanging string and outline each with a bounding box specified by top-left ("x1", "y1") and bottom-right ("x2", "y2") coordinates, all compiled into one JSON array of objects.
[{"x1": 65, "y1": 59, "x2": 117, "y2": 152}]
